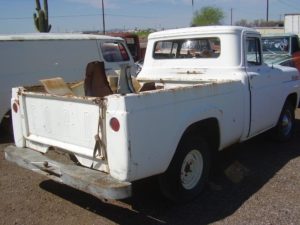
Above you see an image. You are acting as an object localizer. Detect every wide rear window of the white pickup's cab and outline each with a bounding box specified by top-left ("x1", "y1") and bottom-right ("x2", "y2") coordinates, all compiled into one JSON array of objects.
[{"x1": 153, "y1": 37, "x2": 221, "y2": 59}]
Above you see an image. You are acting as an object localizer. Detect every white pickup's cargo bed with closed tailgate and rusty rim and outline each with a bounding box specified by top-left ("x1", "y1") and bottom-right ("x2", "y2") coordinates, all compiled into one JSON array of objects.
[{"x1": 14, "y1": 76, "x2": 243, "y2": 181}]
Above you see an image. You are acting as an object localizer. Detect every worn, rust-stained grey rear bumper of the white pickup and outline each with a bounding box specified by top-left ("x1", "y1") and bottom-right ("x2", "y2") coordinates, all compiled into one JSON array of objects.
[{"x1": 5, "y1": 146, "x2": 131, "y2": 199}]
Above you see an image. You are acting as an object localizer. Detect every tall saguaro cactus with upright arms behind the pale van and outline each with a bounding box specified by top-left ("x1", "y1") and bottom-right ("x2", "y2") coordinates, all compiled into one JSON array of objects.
[{"x1": 33, "y1": 0, "x2": 51, "y2": 33}]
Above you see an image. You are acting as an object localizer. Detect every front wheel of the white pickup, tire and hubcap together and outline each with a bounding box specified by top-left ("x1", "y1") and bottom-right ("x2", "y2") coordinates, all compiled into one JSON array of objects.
[{"x1": 272, "y1": 101, "x2": 295, "y2": 142}]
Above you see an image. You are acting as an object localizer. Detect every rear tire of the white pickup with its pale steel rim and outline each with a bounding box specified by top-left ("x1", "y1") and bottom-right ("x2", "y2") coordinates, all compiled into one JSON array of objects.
[{"x1": 159, "y1": 138, "x2": 211, "y2": 202}]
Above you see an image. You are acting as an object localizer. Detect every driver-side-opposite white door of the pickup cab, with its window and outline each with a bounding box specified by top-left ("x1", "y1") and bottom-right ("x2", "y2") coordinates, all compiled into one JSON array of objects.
[{"x1": 244, "y1": 36, "x2": 281, "y2": 136}]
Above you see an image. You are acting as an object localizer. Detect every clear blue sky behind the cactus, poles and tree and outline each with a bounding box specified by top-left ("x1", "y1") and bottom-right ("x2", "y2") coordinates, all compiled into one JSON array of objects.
[{"x1": 0, "y1": 0, "x2": 300, "y2": 34}]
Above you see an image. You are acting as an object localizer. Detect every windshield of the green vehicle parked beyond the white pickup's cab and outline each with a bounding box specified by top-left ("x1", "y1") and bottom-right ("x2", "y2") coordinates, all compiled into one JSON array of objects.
[{"x1": 262, "y1": 37, "x2": 289, "y2": 54}]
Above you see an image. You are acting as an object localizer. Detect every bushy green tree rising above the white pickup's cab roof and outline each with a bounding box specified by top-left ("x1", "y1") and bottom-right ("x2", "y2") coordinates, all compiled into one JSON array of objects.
[{"x1": 192, "y1": 6, "x2": 224, "y2": 26}]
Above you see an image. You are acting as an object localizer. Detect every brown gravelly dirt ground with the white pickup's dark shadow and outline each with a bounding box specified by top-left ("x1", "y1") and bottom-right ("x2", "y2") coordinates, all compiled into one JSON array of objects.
[{"x1": 0, "y1": 111, "x2": 300, "y2": 225}]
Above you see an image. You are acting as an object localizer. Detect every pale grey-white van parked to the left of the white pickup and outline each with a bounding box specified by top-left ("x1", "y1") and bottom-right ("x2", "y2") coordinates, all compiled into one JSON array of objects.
[{"x1": 0, "y1": 34, "x2": 135, "y2": 142}]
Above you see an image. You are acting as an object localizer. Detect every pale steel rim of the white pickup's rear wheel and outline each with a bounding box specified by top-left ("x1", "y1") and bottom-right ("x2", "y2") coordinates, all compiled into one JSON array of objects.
[{"x1": 180, "y1": 150, "x2": 203, "y2": 190}]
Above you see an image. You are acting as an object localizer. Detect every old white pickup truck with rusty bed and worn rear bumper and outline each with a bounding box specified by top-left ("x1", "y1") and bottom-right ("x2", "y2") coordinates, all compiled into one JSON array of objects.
[{"x1": 5, "y1": 26, "x2": 300, "y2": 202}]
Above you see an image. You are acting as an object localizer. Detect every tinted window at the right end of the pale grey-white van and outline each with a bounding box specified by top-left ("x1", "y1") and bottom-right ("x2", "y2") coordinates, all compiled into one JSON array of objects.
[{"x1": 101, "y1": 42, "x2": 130, "y2": 62}]
